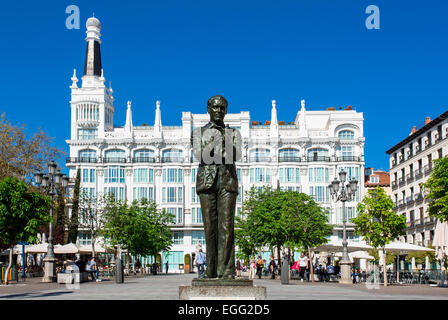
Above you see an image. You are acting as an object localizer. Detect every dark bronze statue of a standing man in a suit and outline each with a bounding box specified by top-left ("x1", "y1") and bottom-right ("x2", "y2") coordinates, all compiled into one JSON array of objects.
[{"x1": 193, "y1": 95, "x2": 241, "y2": 279}]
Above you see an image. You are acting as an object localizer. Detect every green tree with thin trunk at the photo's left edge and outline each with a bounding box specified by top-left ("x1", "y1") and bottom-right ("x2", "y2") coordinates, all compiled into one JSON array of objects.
[{"x1": 0, "y1": 177, "x2": 51, "y2": 284}]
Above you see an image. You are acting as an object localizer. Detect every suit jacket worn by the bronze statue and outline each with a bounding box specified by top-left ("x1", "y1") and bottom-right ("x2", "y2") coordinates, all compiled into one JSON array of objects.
[{"x1": 193, "y1": 122, "x2": 241, "y2": 194}]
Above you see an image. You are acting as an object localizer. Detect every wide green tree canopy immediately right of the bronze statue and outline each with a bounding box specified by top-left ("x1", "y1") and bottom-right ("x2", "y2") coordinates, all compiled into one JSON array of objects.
[{"x1": 235, "y1": 186, "x2": 332, "y2": 258}]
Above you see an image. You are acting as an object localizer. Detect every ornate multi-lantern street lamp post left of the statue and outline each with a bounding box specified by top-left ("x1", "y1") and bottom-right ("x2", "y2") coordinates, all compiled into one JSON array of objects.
[{"x1": 34, "y1": 161, "x2": 69, "y2": 282}]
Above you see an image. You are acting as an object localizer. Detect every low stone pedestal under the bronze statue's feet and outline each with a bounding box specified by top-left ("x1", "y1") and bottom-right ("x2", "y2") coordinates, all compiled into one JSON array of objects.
[{"x1": 179, "y1": 279, "x2": 266, "y2": 300}]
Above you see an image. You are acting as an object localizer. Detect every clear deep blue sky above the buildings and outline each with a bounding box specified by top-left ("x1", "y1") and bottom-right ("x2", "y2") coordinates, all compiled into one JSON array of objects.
[{"x1": 0, "y1": 0, "x2": 448, "y2": 170}]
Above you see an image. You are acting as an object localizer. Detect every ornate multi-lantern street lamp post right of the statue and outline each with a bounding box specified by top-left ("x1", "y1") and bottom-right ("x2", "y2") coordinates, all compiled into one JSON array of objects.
[{"x1": 328, "y1": 171, "x2": 358, "y2": 283}]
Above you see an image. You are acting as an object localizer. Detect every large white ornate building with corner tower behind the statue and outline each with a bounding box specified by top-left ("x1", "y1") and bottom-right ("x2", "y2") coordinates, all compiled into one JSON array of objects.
[{"x1": 67, "y1": 18, "x2": 365, "y2": 271}]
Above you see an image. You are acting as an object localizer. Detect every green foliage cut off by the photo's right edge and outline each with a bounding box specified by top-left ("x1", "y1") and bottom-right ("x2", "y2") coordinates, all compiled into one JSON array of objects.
[{"x1": 423, "y1": 157, "x2": 448, "y2": 222}]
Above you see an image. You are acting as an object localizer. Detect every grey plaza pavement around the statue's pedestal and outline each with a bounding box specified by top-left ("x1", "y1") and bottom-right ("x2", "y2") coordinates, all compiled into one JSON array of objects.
[{"x1": 0, "y1": 274, "x2": 448, "y2": 300}]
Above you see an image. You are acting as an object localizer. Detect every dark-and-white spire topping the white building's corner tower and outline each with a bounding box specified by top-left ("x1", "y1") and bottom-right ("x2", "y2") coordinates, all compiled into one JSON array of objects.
[{"x1": 84, "y1": 17, "x2": 102, "y2": 77}]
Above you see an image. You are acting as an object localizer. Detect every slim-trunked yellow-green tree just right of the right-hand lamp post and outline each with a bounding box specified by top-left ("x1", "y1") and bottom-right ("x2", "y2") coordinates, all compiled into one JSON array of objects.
[{"x1": 351, "y1": 187, "x2": 407, "y2": 286}]
